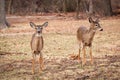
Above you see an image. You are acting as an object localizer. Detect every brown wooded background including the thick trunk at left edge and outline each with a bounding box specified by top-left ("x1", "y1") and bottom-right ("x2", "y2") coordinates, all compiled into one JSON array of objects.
[{"x1": 0, "y1": 0, "x2": 120, "y2": 28}]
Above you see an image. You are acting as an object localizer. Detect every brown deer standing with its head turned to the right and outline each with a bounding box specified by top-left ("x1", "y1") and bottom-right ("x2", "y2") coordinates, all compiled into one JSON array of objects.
[{"x1": 77, "y1": 17, "x2": 103, "y2": 65}]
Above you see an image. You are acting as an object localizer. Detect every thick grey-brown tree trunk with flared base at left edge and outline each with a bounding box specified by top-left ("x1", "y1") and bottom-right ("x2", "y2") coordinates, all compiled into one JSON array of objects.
[{"x1": 0, "y1": 0, "x2": 9, "y2": 29}]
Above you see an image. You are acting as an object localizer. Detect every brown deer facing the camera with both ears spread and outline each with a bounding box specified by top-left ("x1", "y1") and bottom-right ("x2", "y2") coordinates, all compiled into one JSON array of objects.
[{"x1": 30, "y1": 22, "x2": 48, "y2": 74}]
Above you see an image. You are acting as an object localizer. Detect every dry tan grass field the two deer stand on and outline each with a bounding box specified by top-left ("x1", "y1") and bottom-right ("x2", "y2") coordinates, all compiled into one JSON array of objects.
[{"x1": 0, "y1": 16, "x2": 120, "y2": 80}]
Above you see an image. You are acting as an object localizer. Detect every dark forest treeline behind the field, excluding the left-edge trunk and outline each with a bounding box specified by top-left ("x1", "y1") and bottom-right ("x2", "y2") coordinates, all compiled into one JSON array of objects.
[{"x1": 5, "y1": 0, "x2": 120, "y2": 16}]
